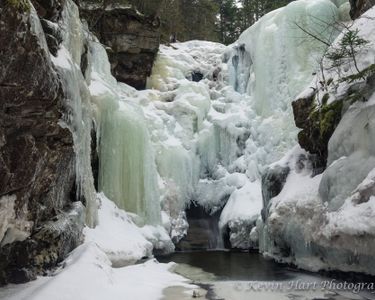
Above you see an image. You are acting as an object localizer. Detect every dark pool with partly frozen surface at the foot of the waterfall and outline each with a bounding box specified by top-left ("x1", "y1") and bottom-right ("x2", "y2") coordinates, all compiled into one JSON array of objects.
[{"x1": 157, "y1": 251, "x2": 375, "y2": 300}]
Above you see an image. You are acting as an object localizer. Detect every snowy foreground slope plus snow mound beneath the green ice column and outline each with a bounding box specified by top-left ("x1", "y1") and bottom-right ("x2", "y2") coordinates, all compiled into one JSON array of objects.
[{"x1": 0, "y1": 195, "x2": 197, "y2": 300}]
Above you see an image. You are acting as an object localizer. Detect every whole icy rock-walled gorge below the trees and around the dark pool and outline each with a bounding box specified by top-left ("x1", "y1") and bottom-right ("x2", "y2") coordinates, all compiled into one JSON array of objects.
[{"x1": 0, "y1": 0, "x2": 375, "y2": 299}]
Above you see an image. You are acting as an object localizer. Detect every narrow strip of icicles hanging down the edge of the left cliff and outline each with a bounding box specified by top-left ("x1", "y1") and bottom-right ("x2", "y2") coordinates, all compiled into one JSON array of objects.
[{"x1": 51, "y1": 1, "x2": 97, "y2": 227}]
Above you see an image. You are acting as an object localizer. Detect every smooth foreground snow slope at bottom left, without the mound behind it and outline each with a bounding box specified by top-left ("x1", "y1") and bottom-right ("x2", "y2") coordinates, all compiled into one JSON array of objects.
[{"x1": 0, "y1": 242, "x2": 195, "y2": 300}]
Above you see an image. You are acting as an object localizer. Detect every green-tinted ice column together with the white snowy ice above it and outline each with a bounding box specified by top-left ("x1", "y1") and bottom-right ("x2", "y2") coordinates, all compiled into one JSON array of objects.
[{"x1": 90, "y1": 42, "x2": 161, "y2": 225}]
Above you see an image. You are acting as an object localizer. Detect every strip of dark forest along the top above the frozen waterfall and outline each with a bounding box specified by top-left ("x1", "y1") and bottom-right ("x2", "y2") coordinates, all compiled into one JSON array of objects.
[{"x1": 86, "y1": 0, "x2": 293, "y2": 44}]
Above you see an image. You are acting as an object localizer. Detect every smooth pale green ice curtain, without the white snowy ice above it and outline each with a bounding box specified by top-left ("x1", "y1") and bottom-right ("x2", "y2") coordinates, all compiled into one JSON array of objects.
[{"x1": 99, "y1": 102, "x2": 160, "y2": 224}]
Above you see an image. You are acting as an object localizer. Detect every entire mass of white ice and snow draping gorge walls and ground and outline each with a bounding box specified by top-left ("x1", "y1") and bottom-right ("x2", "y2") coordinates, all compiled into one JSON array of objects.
[{"x1": 4, "y1": 0, "x2": 375, "y2": 299}]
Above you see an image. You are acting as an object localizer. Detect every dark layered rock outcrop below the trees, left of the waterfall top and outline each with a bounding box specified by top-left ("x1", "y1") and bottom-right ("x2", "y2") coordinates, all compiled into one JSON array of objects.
[{"x1": 79, "y1": 1, "x2": 160, "y2": 90}]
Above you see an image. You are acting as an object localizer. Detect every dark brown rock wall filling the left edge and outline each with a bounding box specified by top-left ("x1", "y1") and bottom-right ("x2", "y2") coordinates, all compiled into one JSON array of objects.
[{"x1": 0, "y1": 1, "x2": 84, "y2": 284}]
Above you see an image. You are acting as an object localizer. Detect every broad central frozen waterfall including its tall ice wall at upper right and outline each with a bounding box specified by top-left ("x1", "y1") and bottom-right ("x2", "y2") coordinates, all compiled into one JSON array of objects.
[{"x1": 145, "y1": 0, "x2": 347, "y2": 247}]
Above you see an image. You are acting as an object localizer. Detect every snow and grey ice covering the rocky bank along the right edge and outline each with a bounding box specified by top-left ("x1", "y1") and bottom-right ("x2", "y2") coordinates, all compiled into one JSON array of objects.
[{"x1": 257, "y1": 8, "x2": 375, "y2": 275}]
